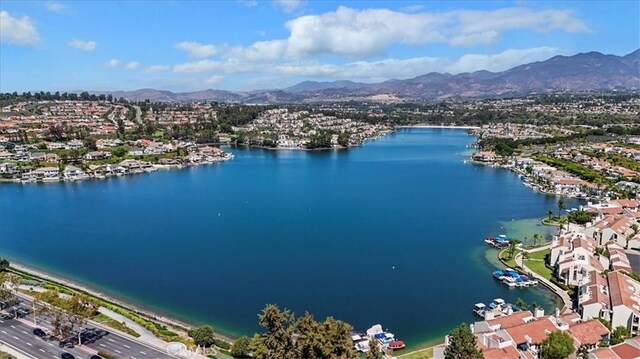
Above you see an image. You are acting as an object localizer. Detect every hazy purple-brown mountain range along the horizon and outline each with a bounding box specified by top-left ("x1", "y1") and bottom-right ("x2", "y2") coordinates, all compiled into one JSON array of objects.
[{"x1": 96, "y1": 50, "x2": 640, "y2": 103}]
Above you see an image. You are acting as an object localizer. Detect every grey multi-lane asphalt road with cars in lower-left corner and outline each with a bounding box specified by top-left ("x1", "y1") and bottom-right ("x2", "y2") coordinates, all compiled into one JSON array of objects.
[{"x1": 0, "y1": 300, "x2": 178, "y2": 359}]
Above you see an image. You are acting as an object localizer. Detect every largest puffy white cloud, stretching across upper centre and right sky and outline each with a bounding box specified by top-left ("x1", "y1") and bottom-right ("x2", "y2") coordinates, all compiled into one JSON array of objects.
[{"x1": 200, "y1": 6, "x2": 587, "y2": 61}]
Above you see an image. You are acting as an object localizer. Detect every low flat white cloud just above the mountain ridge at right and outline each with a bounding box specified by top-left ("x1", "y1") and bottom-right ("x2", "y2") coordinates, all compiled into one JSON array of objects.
[{"x1": 445, "y1": 47, "x2": 558, "y2": 73}]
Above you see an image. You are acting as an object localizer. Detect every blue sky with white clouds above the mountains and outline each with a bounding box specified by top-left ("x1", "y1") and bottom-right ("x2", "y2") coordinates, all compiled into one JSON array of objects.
[{"x1": 0, "y1": 0, "x2": 640, "y2": 92}]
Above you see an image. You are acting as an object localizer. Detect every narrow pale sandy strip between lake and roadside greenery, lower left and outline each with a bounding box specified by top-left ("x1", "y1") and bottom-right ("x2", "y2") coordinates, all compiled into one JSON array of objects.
[{"x1": 11, "y1": 261, "x2": 204, "y2": 339}]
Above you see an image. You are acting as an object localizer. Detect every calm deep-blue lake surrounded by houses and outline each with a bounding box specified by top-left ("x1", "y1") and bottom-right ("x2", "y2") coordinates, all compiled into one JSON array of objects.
[{"x1": 0, "y1": 129, "x2": 575, "y2": 346}]
